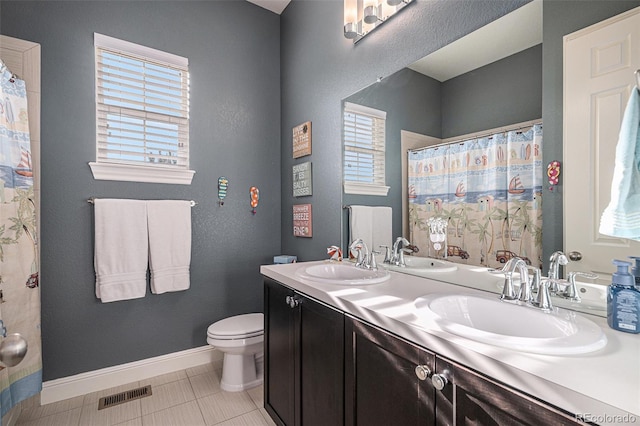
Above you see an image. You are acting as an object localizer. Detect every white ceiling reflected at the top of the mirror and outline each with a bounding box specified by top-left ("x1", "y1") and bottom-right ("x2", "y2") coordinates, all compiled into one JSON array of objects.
[{"x1": 409, "y1": 0, "x2": 542, "y2": 82}]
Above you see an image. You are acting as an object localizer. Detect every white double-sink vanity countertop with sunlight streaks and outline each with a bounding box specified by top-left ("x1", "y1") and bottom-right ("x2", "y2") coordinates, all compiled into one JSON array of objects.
[{"x1": 260, "y1": 261, "x2": 640, "y2": 425}]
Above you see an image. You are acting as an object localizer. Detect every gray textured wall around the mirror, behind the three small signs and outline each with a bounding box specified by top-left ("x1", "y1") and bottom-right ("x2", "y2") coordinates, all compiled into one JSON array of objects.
[{"x1": 280, "y1": 0, "x2": 527, "y2": 260}]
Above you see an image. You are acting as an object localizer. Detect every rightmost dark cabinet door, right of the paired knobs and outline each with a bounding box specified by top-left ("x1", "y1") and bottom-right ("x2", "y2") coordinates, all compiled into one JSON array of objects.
[{"x1": 435, "y1": 357, "x2": 583, "y2": 426}]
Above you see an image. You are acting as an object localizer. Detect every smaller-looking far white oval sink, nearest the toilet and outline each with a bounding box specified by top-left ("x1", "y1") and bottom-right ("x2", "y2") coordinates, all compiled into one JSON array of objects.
[{"x1": 296, "y1": 262, "x2": 391, "y2": 285}]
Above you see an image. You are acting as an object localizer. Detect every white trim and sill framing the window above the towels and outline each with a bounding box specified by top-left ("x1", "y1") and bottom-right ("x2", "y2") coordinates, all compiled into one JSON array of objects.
[{"x1": 89, "y1": 33, "x2": 195, "y2": 185}]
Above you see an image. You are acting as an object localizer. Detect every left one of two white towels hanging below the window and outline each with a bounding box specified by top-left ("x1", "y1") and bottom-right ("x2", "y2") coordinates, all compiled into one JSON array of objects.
[{"x1": 94, "y1": 199, "x2": 149, "y2": 303}]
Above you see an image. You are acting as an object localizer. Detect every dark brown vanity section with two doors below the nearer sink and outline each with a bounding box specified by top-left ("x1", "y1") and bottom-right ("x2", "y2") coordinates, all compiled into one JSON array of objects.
[{"x1": 345, "y1": 317, "x2": 581, "y2": 426}]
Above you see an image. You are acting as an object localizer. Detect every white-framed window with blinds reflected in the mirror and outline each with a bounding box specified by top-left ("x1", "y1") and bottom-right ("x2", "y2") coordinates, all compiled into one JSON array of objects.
[{"x1": 343, "y1": 102, "x2": 389, "y2": 195}]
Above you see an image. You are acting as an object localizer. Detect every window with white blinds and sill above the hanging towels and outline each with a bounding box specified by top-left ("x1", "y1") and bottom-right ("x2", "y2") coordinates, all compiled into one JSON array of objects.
[{"x1": 89, "y1": 34, "x2": 195, "y2": 184}]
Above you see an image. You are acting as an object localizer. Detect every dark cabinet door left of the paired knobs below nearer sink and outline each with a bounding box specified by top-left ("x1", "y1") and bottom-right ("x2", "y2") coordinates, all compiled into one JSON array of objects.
[{"x1": 345, "y1": 317, "x2": 435, "y2": 426}]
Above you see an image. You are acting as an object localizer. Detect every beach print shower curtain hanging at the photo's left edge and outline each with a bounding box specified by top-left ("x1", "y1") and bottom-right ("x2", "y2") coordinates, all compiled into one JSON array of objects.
[{"x1": 0, "y1": 61, "x2": 42, "y2": 416}]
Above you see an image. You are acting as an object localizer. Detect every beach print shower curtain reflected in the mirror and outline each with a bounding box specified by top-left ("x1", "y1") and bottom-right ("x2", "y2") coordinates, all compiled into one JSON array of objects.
[{"x1": 408, "y1": 124, "x2": 542, "y2": 267}]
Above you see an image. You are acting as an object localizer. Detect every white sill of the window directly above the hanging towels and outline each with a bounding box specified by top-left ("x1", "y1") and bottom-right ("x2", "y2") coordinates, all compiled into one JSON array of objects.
[{"x1": 89, "y1": 162, "x2": 195, "y2": 185}]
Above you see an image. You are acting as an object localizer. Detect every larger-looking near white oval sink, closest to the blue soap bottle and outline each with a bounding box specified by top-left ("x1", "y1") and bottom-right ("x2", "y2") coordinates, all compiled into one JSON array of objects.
[{"x1": 414, "y1": 294, "x2": 607, "y2": 355}]
